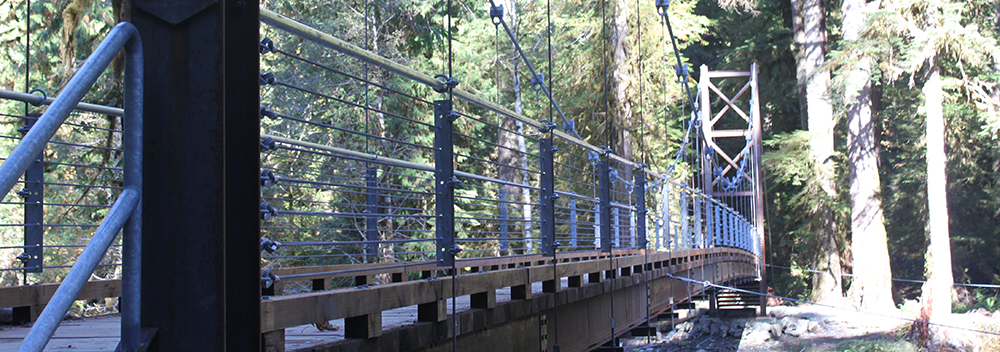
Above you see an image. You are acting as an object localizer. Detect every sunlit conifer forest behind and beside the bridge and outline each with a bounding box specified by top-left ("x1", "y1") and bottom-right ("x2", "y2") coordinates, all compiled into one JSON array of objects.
[{"x1": 0, "y1": 0, "x2": 1000, "y2": 320}]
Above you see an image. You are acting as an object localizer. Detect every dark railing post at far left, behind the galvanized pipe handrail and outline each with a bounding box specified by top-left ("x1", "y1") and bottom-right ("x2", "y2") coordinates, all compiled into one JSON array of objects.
[{"x1": 17, "y1": 114, "x2": 45, "y2": 276}]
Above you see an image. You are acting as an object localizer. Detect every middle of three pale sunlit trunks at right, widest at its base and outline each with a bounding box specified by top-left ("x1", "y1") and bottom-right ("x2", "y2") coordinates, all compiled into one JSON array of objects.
[{"x1": 842, "y1": 0, "x2": 894, "y2": 311}]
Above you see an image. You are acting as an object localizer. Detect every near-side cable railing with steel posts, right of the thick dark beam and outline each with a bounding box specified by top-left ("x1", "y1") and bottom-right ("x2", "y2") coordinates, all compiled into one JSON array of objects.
[{"x1": 260, "y1": 9, "x2": 759, "y2": 285}]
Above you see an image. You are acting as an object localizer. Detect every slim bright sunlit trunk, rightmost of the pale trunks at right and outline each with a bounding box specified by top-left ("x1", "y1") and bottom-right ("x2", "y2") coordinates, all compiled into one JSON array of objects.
[{"x1": 920, "y1": 62, "x2": 954, "y2": 336}]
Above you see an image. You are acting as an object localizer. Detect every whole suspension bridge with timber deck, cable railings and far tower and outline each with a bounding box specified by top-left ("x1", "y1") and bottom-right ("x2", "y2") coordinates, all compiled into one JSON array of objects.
[{"x1": 0, "y1": 1, "x2": 766, "y2": 351}]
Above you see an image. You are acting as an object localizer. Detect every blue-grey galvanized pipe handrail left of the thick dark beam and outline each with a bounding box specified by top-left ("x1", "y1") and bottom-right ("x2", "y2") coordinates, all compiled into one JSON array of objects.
[{"x1": 0, "y1": 23, "x2": 143, "y2": 351}]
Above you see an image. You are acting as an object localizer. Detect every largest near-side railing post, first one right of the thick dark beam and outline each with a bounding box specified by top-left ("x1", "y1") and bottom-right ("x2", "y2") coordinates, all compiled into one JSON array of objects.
[{"x1": 434, "y1": 100, "x2": 460, "y2": 267}]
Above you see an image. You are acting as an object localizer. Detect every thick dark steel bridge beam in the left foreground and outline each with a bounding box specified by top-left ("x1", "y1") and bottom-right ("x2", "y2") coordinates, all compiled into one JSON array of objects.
[{"x1": 131, "y1": 0, "x2": 261, "y2": 351}]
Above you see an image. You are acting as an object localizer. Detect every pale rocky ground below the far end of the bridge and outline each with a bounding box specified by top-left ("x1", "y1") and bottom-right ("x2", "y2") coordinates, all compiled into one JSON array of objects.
[{"x1": 622, "y1": 302, "x2": 1000, "y2": 352}]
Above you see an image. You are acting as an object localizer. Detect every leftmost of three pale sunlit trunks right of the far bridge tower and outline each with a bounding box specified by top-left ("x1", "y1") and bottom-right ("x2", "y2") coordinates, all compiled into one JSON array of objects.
[{"x1": 801, "y1": 0, "x2": 843, "y2": 302}]
